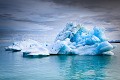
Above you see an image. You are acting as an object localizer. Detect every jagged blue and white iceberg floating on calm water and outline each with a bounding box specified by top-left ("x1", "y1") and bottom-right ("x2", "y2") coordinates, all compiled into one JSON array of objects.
[{"x1": 6, "y1": 23, "x2": 114, "y2": 55}]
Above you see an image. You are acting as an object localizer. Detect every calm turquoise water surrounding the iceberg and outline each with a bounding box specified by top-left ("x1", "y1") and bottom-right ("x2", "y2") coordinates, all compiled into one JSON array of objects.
[{"x1": 0, "y1": 31, "x2": 120, "y2": 80}]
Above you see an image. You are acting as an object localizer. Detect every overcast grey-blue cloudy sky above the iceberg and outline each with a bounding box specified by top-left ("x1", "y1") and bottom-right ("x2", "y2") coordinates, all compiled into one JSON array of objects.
[{"x1": 0, "y1": 0, "x2": 120, "y2": 40}]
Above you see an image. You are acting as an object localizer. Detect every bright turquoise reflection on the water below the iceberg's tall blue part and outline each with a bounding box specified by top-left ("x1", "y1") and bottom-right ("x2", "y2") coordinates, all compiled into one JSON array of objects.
[{"x1": 53, "y1": 55, "x2": 111, "y2": 80}]
